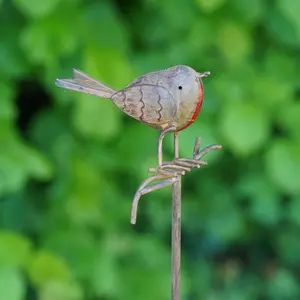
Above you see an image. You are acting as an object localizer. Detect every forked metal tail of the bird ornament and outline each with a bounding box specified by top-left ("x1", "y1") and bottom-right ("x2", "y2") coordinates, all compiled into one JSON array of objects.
[{"x1": 55, "y1": 69, "x2": 117, "y2": 99}]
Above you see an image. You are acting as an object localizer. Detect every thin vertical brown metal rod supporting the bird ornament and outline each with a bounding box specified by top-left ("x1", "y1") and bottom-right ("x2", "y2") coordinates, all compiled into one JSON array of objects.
[{"x1": 171, "y1": 132, "x2": 181, "y2": 300}]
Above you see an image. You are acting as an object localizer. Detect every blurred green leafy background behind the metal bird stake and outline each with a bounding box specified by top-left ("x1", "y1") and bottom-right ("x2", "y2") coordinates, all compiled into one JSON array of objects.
[{"x1": 0, "y1": 0, "x2": 300, "y2": 300}]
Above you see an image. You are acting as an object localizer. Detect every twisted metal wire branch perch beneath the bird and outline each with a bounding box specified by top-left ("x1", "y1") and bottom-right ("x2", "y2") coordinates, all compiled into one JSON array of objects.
[{"x1": 130, "y1": 138, "x2": 222, "y2": 224}]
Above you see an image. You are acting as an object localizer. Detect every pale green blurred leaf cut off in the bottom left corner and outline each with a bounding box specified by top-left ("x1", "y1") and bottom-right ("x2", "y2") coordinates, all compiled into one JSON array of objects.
[{"x1": 0, "y1": 267, "x2": 26, "y2": 300}]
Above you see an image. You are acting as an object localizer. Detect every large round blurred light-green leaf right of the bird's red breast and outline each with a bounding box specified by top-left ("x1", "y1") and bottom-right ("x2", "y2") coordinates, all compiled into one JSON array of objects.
[{"x1": 219, "y1": 102, "x2": 270, "y2": 155}]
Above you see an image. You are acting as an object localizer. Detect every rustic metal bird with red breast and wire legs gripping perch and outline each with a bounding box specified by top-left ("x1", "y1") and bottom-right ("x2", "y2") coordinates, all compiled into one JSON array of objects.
[{"x1": 56, "y1": 65, "x2": 219, "y2": 222}]
